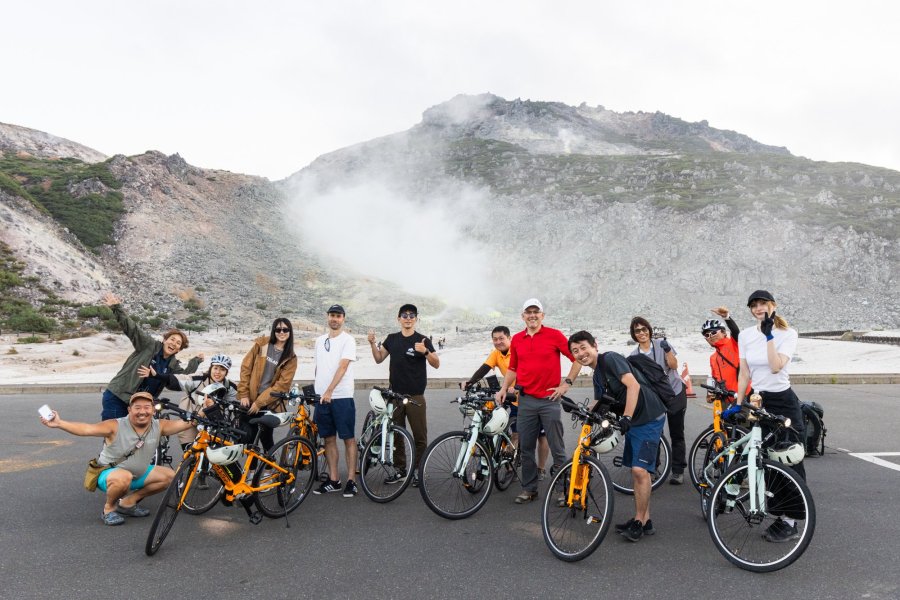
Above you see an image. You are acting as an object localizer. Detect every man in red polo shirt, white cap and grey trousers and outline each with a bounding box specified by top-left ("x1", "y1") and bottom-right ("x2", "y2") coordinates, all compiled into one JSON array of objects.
[{"x1": 496, "y1": 298, "x2": 581, "y2": 504}]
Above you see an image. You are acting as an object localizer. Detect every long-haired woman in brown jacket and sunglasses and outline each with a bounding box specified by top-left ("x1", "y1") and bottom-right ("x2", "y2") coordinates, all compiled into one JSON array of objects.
[{"x1": 238, "y1": 318, "x2": 297, "y2": 450}]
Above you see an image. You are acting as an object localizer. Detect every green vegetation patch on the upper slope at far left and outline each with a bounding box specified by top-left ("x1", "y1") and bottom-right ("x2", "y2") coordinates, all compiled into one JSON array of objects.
[{"x1": 0, "y1": 155, "x2": 124, "y2": 250}]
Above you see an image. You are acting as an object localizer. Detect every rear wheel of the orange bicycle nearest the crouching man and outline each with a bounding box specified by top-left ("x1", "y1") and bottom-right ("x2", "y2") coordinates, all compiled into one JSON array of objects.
[{"x1": 253, "y1": 436, "x2": 316, "y2": 519}]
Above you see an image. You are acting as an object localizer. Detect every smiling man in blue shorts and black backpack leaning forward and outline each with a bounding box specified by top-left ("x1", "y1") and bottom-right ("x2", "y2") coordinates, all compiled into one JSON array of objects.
[{"x1": 569, "y1": 331, "x2": 666, "y2": 542}]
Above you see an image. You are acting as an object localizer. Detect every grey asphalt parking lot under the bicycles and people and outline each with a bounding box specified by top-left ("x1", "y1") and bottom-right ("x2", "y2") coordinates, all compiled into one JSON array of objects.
[{"x1": 0, "y1": 385, "x2": 900, "y2": 600}]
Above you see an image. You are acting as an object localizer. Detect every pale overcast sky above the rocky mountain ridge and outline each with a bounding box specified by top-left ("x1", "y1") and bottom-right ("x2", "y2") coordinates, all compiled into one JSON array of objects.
[{"x1": 0, "y1": 0, "x2": 900, "y2": 179}]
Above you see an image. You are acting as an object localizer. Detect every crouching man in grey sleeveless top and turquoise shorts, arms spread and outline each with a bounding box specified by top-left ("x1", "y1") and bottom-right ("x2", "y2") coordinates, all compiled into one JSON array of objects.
[{"x1": 41, "y1": 392, "x2": 197, "y2": 525}]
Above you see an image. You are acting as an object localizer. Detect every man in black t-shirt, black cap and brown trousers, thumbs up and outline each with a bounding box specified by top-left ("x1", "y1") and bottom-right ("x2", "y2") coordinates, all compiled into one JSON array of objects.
[{"x1": 368, "y1": 304, "x2": 441, "y2": 487}]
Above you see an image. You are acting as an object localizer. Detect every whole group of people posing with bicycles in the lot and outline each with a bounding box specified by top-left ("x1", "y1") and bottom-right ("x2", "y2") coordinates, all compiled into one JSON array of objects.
[{"x1": 41, "y1": 290, "x2": 805, "y2": 541}]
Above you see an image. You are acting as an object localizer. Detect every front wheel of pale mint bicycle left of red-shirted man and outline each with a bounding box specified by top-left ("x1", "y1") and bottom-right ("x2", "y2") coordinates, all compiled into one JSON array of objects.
[{"x1": 419, "y1": 431, "x2": 492, "y2": 519}]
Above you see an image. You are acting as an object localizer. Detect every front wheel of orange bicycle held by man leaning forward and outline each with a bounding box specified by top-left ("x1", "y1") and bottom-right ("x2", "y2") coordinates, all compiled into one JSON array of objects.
[{"x1": 541, "y1": 456, "x2": 614, "y2": 562}]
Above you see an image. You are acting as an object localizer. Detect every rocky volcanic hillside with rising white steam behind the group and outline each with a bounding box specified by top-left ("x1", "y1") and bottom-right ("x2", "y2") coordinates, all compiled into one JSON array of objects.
[{"x1": 0, "y1": 95, "x2": 900, "y2": 331}]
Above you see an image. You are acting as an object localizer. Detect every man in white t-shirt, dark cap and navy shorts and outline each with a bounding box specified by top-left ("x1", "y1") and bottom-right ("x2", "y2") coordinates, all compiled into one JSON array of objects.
[{"x1": 313, "y1": 304, "x2": 357, "y2": 498}]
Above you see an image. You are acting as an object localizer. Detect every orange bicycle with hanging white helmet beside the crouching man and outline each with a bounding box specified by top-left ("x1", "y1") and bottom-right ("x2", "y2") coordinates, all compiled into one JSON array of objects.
[{"x1": 144, "y1": 404, "x2": 315, "y2": 556}]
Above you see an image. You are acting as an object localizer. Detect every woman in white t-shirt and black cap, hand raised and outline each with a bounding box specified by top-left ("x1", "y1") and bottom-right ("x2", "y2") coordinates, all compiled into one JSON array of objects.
[{"x1": 737, "y1": 290, "x2": 806, "y2": 479}]
